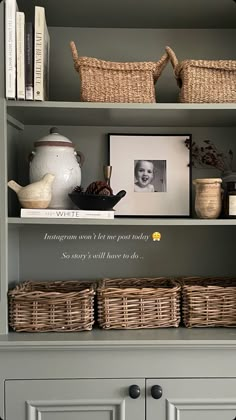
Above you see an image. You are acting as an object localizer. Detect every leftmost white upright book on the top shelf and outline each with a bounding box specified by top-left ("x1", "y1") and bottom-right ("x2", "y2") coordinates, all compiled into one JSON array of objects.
[{"x1": 5, "y1": 0, "x2": 18, "y2": 99}]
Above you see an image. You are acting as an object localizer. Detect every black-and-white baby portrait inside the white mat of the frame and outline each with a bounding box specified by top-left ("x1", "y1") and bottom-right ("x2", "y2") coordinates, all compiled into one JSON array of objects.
[{"x1": 134, "y1": 159, "x2": 166, "y2": 193}]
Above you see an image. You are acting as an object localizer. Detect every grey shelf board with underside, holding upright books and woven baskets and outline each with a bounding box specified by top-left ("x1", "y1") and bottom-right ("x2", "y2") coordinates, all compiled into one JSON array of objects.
[{"x1": 7, "y1": 102, "x2": 236, "y2": 127}]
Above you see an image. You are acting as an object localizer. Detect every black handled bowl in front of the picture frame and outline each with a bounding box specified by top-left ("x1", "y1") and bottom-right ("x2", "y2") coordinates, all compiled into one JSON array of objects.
[{"x1": 68, "y1": 190, "x2": 126, "y2": 210}]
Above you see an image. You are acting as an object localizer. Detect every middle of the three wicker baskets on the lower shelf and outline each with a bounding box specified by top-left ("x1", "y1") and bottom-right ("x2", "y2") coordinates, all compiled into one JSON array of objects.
[{"x1": 97, "y1": 277, "x2": 180, "y2": 329}]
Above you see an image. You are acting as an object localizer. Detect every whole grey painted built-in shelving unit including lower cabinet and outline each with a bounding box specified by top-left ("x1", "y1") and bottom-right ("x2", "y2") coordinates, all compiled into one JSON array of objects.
[{"x1": 0, "y1": 0, "x2": 236, "y2": 420}]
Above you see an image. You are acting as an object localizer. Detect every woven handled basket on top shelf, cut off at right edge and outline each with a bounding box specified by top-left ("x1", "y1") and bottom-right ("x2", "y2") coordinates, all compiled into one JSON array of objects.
[{"x1": 166, "y1": 47, "x2": 236, "y2": 103}]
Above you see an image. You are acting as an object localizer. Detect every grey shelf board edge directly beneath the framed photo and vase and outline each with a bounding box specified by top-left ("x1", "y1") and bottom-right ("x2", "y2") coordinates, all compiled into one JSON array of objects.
[{"x1": 8, "y1": 217, "x2": 236, "y2": 226}]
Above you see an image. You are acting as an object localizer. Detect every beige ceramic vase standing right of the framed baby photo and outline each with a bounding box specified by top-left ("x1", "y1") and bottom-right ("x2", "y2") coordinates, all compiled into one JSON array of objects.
[{"x1": 193, "y1": 178, "x2": 222, "y2": 219}]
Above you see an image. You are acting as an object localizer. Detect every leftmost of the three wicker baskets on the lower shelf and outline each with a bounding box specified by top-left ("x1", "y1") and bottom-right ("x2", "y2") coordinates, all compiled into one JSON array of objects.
[{"x1": 8, "y1": 281, "x2": 95, "y2": 332}]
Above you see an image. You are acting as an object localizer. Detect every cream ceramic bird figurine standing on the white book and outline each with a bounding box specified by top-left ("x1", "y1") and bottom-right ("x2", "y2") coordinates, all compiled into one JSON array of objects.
[{"x1": 7, "y1": 174, "x2": 55, "y2": 209}]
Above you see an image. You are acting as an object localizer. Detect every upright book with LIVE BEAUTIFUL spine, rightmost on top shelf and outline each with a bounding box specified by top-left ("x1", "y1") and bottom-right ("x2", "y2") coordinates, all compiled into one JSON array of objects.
[{"x1": 34, "y1": 6, "x2": 45, "y2": 101}]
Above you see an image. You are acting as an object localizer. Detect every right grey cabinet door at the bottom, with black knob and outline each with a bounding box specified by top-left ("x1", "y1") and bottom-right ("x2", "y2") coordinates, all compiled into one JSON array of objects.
[{"x1": 146, "y1": 378, "x2": 236, "y2": 420}]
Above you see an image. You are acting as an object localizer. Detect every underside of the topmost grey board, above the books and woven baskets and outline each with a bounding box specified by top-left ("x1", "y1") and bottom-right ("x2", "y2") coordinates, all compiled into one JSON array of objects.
[{"x1": 17, "y1": 0, "x2": 236, "y2": 28}]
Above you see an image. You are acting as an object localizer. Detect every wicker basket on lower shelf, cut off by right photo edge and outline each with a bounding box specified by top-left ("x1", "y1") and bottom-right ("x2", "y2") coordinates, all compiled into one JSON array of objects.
[{"x1": 182, "y1": 277, "x2": 236, "y2": 327}]
